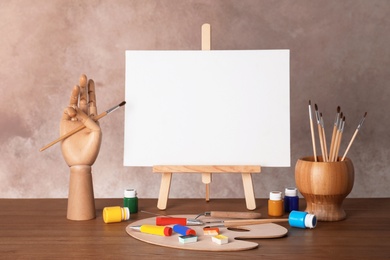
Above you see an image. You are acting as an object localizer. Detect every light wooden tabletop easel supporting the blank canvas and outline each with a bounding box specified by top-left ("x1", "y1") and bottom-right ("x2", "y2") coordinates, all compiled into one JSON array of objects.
[{"x1": 153, "y1": 24, "x2": 261, "y2": 210}]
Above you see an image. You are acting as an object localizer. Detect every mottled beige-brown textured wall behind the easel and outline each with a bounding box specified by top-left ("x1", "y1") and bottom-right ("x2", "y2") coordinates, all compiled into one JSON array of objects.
[{"x1": 0, "y1": 0, "x2": 390, "y2": 198}]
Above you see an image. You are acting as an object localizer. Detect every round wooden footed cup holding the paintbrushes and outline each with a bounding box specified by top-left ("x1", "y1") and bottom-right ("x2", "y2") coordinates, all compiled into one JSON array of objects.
[{"x1": 295, "y1": 156, "x2": 354, "y2": 221}]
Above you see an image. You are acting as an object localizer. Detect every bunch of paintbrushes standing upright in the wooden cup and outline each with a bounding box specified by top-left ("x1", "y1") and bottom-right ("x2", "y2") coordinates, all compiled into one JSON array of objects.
[{"x1": 309, "y1": 100, "x2": 367, "y2": 162}]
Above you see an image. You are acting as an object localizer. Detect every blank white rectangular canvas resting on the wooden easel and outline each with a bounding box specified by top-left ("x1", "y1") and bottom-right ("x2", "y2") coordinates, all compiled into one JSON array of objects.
[{"x1": 124, "y1": 50, "x2": 290, "y2": 167}]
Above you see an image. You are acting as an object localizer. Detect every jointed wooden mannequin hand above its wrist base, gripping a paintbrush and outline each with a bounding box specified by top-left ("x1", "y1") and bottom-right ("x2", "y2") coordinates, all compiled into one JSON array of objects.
[{"x1": 60, "y1": 75, "x2": 102, "y2": 167}]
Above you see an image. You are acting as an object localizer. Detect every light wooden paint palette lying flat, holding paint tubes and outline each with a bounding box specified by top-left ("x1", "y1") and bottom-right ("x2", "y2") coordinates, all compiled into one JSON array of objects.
[{"x1": 126, "y1": 215, "x2": 288, "y2": 251}]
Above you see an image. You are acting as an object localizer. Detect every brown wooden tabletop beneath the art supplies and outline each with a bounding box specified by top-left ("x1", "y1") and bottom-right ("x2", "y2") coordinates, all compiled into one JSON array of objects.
[{"x1": 0, "y1": 198, "x2": 390, "y2": 259}]
